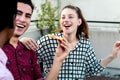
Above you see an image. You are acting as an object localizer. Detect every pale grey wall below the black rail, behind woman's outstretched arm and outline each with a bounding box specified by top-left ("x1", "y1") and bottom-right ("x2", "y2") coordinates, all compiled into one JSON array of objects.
[{"x1": 90, "y1": 30, "x2": 120, "y2": 69}]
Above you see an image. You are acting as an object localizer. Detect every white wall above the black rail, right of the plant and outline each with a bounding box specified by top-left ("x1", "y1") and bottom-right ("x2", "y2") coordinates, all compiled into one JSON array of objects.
[{"x1": 60, "y1": 0, "x2": 120, "y2": 21}]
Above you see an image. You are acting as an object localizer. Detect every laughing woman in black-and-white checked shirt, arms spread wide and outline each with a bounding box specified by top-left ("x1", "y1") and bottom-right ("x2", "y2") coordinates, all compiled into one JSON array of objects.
[{"x1": 22, "y1": 5, "x2": 120, "y2": 80}]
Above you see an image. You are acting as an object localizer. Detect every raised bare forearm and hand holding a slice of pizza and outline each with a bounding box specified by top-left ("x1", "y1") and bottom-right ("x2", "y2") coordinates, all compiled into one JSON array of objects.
[{"x1": 45, "y1": 40, "x2": 70, "y2": 80}]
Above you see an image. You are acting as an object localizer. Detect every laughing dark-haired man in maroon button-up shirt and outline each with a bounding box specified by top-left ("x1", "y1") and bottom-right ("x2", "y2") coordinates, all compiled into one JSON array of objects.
[{"x1": 3, "y1": 0, "x2": 69, "y2": 80}]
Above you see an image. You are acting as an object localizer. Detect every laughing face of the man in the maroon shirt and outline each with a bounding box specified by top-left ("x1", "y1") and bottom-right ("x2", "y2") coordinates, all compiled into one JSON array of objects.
[{"x1": 14, "y1": 2, "x2": 32, "y2": 37}]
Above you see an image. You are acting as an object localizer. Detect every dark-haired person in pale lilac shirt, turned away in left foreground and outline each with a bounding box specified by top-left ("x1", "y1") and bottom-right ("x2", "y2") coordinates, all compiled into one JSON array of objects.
[{"x1": 0, "y1": 0, "x2": 17, "y2": 80}]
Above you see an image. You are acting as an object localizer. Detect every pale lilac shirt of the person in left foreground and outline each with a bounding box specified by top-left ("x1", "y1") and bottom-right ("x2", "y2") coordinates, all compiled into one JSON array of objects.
[{"x1": 0, "y1": 48, "x2": 14, "y2": 80}]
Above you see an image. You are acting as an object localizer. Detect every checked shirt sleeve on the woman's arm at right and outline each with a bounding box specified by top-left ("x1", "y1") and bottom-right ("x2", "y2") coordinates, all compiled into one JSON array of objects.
[{"x1": 86, "y1": 42, "x2": 104, "y2": 76}]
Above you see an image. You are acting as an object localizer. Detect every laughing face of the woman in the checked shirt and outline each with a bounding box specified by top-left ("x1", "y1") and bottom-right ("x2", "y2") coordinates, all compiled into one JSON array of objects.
[{"x1": 60, "y1": 8, "x2": 81, "y2": 35}]
